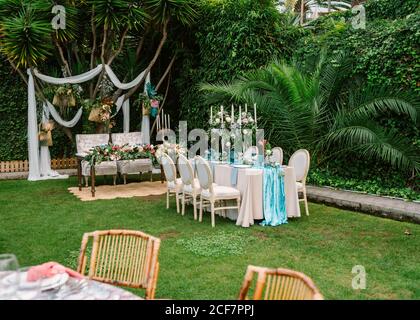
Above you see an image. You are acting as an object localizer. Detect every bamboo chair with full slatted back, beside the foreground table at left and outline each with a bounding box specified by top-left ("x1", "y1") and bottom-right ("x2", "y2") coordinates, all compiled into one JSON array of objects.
[{"x1": 77, "y1": 230, "x2": 160, "y2": 299}]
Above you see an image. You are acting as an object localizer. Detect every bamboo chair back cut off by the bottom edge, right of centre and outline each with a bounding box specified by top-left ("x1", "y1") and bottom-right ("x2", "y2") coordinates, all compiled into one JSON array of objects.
[{"x1": 239, "y1": 265, "x2": 324, "y2": 300}]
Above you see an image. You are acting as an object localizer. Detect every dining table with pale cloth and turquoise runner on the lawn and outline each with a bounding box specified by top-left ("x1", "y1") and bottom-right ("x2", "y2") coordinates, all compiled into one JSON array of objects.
[{"x1": 191, "y1": 155, "x2": 301, "y2": 228}]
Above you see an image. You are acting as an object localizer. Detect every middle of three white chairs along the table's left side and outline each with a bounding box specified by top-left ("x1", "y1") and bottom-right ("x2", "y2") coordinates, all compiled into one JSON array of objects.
[{"x1": 178, "y1": 154, "x2": 201, "y2": 220}]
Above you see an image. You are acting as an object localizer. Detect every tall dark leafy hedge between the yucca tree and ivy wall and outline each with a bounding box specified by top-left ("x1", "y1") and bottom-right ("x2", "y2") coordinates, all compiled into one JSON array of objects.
[{"x1": 176, "y1": 0, "x2": 305, "y2": 128}]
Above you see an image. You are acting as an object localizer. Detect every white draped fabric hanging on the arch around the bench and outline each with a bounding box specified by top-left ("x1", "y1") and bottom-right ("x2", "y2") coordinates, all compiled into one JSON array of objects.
[{"x1": 27, "y1": 64, "x2": 150, "y2": 181}]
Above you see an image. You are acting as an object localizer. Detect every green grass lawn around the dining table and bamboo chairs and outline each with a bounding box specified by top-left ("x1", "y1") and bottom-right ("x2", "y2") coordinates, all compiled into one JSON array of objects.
[{"x1": 0, "y1": 178, "x2": 420, "y2": 299}]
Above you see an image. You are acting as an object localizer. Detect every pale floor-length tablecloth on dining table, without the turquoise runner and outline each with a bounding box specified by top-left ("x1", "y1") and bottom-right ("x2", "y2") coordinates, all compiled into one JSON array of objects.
[{"x1": 214, "y1": 164, "x2": 300, "y2": 227}]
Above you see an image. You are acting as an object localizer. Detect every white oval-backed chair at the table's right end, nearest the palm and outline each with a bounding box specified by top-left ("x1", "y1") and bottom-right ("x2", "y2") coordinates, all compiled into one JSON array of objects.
[{"x1": 289, "y1": 149, "x2": 310, "y2": 216}]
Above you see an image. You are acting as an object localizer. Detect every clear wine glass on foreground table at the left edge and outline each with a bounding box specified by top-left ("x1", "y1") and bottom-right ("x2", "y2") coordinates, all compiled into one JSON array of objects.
[{"x1": 0, "y1": 254, "x2": 19, "y2": 300}]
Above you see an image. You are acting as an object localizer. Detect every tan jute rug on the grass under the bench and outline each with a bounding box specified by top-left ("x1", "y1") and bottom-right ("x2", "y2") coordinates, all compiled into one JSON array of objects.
[{"x1": 68, "y1": 181, "x2": 166, "y2": 201}]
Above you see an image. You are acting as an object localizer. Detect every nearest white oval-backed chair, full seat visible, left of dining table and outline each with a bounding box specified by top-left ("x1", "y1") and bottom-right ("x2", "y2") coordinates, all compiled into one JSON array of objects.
[{"x1": 195, "y1": 156, "x2": 241, "y2": 227}]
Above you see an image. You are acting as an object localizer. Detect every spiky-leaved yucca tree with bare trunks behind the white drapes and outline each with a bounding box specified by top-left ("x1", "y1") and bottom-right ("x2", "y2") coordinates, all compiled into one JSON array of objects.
[{"x1": 0, "y1": 0, "x2": 197, "y2": 140}]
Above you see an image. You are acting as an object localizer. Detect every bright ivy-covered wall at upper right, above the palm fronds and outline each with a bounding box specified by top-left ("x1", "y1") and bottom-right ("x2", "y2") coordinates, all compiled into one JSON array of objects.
[{"x1": 295, "y1": 7, "x2": 420, "y2": 91}]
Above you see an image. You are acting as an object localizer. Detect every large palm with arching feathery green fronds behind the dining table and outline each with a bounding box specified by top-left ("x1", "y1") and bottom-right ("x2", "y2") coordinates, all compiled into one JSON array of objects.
[{"x1": 201, "y1": 55, "x2": 420, "y2": 172}]
